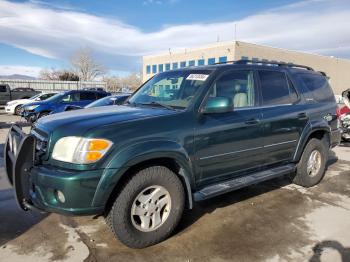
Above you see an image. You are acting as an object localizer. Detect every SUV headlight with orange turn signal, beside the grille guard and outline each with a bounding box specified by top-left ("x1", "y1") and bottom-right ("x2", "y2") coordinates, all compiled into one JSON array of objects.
[{"x1": 52, "y1": 136, "x2": 113, "y2": 164}]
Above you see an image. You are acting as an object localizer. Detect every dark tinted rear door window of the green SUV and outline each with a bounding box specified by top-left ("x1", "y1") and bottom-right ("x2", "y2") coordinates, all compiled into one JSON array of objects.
[{"x1": 259, "y1": 71, "x2": 292, "y2": 105}]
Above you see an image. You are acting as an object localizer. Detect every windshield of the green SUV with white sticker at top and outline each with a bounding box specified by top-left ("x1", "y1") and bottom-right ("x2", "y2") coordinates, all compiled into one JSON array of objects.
[{"x1": 128, "y1": 70, "x2": 213, "y2": 109}]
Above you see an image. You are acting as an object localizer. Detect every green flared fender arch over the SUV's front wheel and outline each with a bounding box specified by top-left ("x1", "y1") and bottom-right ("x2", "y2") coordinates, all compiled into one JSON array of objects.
[{"x1": 92, "y1": 140, "x2": 194, "y2": 208}]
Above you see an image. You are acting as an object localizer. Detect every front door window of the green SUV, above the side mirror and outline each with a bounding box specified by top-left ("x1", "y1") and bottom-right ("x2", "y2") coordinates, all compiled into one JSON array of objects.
[{"x1": 209, "y1": 70, "x2": 256, "y2": 108}]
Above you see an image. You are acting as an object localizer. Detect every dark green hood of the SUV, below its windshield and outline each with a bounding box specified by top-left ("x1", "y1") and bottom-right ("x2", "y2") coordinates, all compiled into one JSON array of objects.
[{"x1": 35, "y1": 105, "x2": 178, "y2": 133}]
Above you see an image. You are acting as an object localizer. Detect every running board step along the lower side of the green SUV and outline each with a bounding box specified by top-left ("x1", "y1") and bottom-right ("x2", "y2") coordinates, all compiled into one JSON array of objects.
[{"x1": 194, "y1": 164, "x2": 296, "y2": 201}]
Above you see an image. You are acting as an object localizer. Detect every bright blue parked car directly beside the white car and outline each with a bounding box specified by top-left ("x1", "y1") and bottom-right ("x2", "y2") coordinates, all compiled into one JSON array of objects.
[{"x1": 21, "y1": 90, "x2": 110, "y2": 123}]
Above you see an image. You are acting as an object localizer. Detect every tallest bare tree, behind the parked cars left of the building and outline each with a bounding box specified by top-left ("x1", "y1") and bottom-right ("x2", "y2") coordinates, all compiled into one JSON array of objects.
[{"x1": 71, "y1": 48, "x2": 105, "y2": 81}]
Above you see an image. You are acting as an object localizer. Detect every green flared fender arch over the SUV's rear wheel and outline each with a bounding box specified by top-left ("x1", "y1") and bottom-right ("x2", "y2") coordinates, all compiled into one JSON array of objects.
[{"x1": 293, "y1": 120, "x2": 331, "y2": 162}]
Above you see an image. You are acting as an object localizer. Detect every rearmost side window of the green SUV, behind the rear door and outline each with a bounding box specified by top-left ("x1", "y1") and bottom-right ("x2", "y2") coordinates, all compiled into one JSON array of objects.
[{"x1": 298, "y1": 73, "x2": 334, "y2": 102}]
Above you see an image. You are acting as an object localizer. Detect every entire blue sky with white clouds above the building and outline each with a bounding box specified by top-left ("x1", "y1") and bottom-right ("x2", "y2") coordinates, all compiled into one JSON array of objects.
[{"x1": 0, "y1": 0, "x2": 350, "y2": 75}]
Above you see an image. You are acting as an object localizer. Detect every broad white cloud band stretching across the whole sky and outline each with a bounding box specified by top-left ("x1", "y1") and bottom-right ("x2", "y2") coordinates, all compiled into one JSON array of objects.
[{"x1": 0, "y1": 0, "x2": 350, "y2": 70}]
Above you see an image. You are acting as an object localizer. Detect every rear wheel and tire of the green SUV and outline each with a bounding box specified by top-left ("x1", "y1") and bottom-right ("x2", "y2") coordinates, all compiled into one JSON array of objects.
[{"x1": 293, "y1": 138, "x2": 328, "y2": 187}]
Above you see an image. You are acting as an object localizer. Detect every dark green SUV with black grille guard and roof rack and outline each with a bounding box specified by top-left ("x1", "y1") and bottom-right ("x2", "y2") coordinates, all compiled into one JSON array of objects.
[{"x1": 4, "y1": 61, "x2": 340, "y2": 248}]
